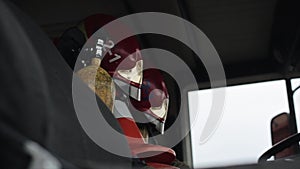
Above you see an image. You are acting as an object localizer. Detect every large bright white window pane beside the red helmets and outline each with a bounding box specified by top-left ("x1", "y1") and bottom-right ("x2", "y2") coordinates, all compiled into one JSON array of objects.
[{"x1": 188, "y1": 80, "x2": 290, "y2": 168}]
